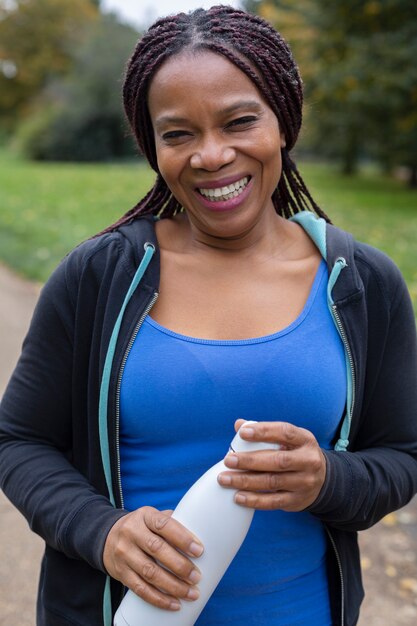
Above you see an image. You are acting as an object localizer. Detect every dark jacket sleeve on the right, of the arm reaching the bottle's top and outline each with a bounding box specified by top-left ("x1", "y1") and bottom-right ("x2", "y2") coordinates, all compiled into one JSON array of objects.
[{"x1": 308, "y1": 258, "x2": 417, "y2": 531}]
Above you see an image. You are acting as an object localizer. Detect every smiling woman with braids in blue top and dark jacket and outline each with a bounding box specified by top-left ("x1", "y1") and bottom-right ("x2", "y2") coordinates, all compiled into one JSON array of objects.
[{"x1": 0, "y1": 7, "x2": 417, "y2": 626}]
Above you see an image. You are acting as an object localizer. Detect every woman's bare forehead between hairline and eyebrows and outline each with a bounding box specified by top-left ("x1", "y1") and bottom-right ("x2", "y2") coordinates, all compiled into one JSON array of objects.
[{"x1": 148, "y1": 51, "x2": 266, "y2": 121}]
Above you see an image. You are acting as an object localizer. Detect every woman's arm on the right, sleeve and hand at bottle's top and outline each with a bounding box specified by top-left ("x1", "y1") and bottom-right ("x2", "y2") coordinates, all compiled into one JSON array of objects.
[{"x1": 219, "y1": 266, "x2": 417, "y2": 530}]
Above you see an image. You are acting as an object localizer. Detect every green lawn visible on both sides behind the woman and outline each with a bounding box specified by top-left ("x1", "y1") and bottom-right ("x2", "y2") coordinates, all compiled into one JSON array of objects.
[{"x1": 0, "y1": 151, "x2": 417, "y2": 311}]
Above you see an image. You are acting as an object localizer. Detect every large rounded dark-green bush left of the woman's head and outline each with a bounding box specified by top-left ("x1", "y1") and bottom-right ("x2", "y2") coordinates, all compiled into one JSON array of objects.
[{"x1": 14, "y1": 16, "x2": 138, "y2": 161}]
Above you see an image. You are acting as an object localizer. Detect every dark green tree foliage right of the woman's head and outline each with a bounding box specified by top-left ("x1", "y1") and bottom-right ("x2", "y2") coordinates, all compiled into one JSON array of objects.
[{"x1": 242, "y1": 0, "x2": 417, "y2": 184}]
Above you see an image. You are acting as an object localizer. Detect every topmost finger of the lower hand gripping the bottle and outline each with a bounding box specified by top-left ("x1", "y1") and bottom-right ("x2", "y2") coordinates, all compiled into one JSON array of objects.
[{"x1": 143, "y1": 507, "x2": 204, "y2": 557}]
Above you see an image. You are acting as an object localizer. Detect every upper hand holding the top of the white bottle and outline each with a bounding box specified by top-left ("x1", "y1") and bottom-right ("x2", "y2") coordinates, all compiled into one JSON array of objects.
[{"x1": 218, "y1": 420, "x2": 326, "y2": 511}]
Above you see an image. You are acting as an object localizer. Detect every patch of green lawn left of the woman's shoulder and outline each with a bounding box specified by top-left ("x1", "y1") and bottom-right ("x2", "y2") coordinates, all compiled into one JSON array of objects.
[{"x1": 0, "y1": 147, "x2": 155, "y2": 282}]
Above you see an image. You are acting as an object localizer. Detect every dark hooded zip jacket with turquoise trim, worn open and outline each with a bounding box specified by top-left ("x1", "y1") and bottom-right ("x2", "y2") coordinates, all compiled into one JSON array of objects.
[{"x1": 0, "y1": 213, "x2": 417, "y2": 626}]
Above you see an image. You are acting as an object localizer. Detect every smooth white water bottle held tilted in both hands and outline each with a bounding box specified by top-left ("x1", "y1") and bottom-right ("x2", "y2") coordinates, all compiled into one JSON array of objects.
[{"x1": 114, "y1": 422, "x2": 279, "y2": 626}]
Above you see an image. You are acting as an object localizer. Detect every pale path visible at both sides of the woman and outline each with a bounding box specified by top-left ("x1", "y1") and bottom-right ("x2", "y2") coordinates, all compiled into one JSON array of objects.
[{"x1": 0, "y1": 265, "x2": 417, "y2": 626}]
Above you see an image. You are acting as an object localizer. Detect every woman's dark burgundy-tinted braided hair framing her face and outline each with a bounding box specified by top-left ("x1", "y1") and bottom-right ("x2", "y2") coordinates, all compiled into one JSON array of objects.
[{"x1": 104, "y1": 5, "x2": 330, "y2": 232}]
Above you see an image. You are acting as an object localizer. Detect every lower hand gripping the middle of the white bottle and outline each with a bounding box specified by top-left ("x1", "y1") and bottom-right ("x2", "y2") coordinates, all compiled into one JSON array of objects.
[{"x1": 103, "y1": 506, "x2": 203, "y2": 611}]
